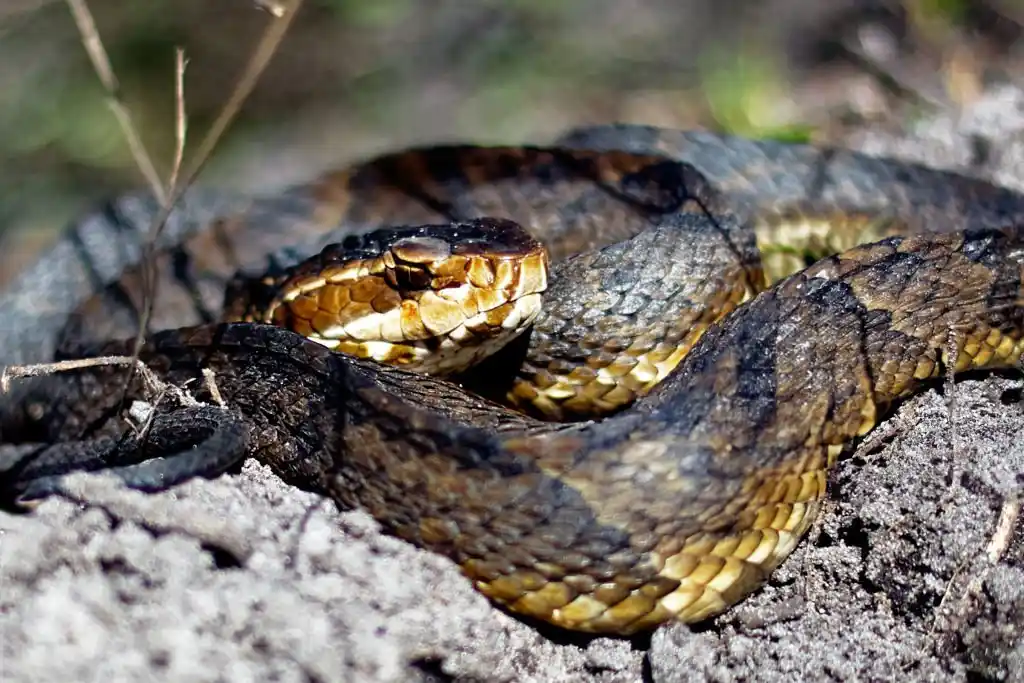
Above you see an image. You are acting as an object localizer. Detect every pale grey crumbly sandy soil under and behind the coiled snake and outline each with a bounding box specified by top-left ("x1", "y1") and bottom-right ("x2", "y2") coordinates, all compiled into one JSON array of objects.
[{"x1": 0, "y1": 90, "x2": 1024, "y2": 682}]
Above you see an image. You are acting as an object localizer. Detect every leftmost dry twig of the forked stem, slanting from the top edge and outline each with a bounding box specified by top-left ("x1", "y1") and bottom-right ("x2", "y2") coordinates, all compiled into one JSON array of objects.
[{"x1": 67, "y1": 0, "x2": 168, "y2": 204}]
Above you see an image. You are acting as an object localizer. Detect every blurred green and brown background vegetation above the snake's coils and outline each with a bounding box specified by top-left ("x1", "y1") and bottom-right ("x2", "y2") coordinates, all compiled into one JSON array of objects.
[{"x1": 0, "y1": 0, "x2": 1024, "y2": 284}]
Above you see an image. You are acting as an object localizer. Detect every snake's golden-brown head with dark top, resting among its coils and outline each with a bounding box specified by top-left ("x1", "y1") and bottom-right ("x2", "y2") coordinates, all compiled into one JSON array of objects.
[{"x1": 241, "y1": 218, "x2": 549, "y2": 375}]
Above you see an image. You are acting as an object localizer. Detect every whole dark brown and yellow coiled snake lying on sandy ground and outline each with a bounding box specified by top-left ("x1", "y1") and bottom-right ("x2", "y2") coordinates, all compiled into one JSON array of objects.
[{"x1": 0, "y1": 124, "x2": 1024, "y2": 636}]
